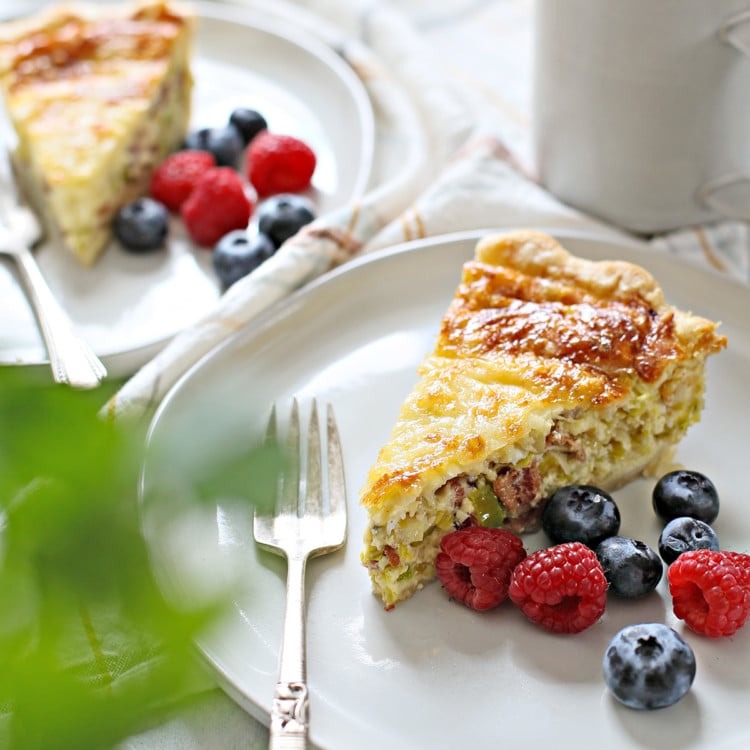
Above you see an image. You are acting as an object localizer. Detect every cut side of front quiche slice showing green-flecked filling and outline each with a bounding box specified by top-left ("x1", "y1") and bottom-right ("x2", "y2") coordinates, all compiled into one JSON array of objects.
[{"x1": 363, "y1": 362, "x2": 702, "y2": 606}]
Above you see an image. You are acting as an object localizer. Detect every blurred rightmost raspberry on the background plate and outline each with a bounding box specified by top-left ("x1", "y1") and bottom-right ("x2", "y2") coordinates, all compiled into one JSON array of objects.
[{"x1": 246, "y1": 130, "x2": 316, "y2": 196}]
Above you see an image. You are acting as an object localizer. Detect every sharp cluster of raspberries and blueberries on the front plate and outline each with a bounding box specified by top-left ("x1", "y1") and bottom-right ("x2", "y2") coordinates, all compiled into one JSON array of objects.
[{"x1": 436, "y1": 470, "x2": 750, "y2": 708}]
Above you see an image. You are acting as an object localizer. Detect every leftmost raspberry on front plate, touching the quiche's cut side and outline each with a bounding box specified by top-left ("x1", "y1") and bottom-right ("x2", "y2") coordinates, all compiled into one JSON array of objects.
[{"x1": 435, "y1": 526, "x2": 526, "y2": 611}]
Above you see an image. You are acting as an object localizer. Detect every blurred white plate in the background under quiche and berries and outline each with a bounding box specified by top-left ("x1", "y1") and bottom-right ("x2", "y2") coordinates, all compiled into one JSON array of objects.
[{"x1": 0, "y1": 4, "x2": 373, "y2": 376}]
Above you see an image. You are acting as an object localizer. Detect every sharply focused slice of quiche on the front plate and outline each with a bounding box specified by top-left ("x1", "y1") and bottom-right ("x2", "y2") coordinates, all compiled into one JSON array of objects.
[{"x1": 360, "y1": 231, "x2": 726, "y2": 609}]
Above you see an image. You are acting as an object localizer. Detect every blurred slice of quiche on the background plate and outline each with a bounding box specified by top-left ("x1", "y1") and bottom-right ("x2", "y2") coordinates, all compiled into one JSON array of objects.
[{"x1": 0, "y1": 0, "x2": 194, "y2": 266}]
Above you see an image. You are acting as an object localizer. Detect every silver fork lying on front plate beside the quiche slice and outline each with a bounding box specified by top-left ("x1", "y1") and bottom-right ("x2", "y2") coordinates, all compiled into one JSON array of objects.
[{"x1": 254, "y1": 399, "x2": 346, "y2": 750}]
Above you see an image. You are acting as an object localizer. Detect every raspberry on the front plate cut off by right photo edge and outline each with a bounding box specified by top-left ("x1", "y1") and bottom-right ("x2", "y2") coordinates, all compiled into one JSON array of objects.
[{"x1": 667, "y1": 549, "x2": 750, "y2": 638}]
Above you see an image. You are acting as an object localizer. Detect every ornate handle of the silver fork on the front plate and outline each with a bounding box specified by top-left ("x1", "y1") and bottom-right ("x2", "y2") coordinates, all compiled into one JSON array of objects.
[{"x1": 268, "y1": 555, "x2": 309, "y2": 750}]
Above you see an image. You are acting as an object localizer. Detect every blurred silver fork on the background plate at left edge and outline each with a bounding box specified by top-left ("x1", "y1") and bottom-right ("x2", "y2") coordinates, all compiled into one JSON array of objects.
[{"x1": 0, "y1": 146, "x2": 107, "y2": 388}]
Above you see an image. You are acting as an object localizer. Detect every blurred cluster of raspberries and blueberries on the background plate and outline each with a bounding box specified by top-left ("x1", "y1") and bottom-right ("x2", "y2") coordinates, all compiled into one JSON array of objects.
[{"x1": 114, "y1": 108, "x2": 317, "y2": 287}]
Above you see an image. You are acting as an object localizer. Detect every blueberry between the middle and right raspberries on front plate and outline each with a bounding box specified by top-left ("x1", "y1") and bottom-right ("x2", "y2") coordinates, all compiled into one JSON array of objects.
[{"x1": 595, "y1": 536, "x2": 664, "y2": 599}]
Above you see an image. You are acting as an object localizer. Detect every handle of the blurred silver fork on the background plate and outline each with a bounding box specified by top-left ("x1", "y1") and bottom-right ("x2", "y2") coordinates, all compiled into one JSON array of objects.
[{"x1": 13, "y1": 247, "x2": 107, "y2": 388}]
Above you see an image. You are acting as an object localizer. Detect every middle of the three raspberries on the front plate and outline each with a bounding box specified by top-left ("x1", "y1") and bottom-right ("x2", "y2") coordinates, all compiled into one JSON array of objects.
[{"x1": 508, "y1": 542, "x2": 607, "y2": 633}]
